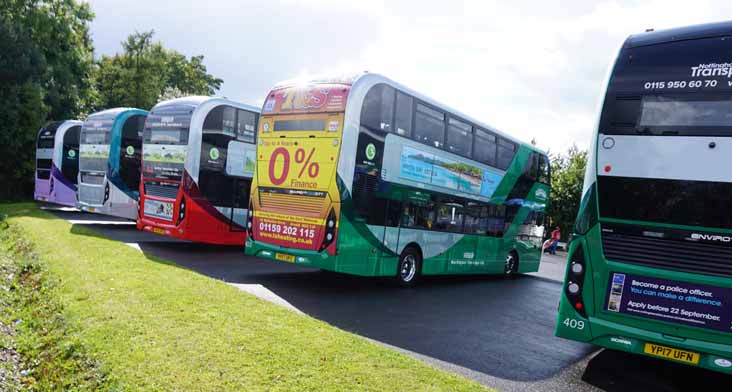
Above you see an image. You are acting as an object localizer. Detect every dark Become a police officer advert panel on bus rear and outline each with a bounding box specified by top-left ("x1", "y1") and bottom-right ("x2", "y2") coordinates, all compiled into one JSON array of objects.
[{"x1": 605, "y1": 273, "x2": 732, "y2": 332}]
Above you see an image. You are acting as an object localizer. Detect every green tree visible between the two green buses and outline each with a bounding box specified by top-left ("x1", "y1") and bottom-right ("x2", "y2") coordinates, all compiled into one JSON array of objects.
[{"x1": 548, "y1": 145, "x2": 587, "y2": 240}]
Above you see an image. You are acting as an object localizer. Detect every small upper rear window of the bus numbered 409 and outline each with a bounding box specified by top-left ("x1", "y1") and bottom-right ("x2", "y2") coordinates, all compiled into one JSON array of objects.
[{"x1": 639, "y1": 96, "x2": 732, "y2": 127}]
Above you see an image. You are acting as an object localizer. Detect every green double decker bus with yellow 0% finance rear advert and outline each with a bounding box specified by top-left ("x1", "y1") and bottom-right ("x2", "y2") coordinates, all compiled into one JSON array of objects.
[{"x1": 246, "y1": 73, "x2": 550, "y2": 285}]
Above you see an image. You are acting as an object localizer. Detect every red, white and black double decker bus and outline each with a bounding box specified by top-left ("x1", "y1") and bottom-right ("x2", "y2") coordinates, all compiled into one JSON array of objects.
[{"x1": 137, "y1": 96, "x2": 259, "y2": 245}]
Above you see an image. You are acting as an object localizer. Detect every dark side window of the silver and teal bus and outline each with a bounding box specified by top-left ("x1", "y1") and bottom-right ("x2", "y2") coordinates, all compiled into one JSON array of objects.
[{"x1": 119, "y1": 115, "x2": 146, "y2": 191}]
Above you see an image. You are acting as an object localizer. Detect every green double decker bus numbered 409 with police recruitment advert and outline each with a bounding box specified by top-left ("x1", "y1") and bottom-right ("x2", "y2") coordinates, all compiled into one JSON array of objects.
[{"x1": 556, "y1": 23, "x2": 732, "y2": 374}]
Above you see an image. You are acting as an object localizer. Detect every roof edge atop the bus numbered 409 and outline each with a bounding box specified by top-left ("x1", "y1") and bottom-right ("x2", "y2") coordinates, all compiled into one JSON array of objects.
[{"x1": 624, "y1": 22, "x2": 732, "y2": 48}]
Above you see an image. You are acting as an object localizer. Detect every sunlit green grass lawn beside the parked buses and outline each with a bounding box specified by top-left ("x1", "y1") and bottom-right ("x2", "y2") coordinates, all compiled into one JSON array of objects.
[{"x1": 0, "y1": 204, "x2": 486, "y2": 391}]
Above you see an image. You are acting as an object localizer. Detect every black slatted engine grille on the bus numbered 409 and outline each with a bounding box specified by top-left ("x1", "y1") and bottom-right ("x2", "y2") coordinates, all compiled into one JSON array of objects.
[{"x1": 602, "y1": 229, "x2": 732, "y2": 277}]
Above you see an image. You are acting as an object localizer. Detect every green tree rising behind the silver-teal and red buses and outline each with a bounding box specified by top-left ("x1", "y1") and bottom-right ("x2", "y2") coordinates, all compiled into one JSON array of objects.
[{"x1": 97, "y1": 31, "x2": 223, "y2": 109}]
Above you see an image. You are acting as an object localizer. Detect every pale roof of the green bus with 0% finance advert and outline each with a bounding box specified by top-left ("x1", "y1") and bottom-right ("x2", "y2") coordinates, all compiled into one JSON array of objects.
[{"x1": 272, "y1": 72, "x2": 546, "y2": 155}]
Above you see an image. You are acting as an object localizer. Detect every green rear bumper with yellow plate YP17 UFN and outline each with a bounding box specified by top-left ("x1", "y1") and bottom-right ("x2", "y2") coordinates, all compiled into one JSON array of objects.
[{"x1": 556, "y1": 301, "x2": 732, "y2": 374}]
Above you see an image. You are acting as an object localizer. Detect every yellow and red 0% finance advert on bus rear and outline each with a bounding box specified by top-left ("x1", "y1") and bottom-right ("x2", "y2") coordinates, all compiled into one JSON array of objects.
[{"x1": 252, "y1": 110, "x2": 343, "y2": 252}]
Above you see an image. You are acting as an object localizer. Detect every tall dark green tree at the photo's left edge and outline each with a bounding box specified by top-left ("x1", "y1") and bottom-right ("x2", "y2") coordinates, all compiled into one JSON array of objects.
[{"x1": 0, "y1": 0, "x2": 95, "y2": 200}]
